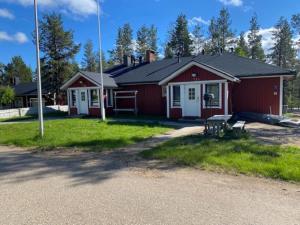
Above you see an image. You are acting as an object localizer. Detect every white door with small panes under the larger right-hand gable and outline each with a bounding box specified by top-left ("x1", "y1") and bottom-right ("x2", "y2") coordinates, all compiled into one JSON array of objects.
[{"x1": 184, "y1": 84, "x2": 201, "y2": 117}]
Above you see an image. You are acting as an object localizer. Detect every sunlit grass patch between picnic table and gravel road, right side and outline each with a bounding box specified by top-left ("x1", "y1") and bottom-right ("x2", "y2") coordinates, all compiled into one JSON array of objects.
[{"x1": 142, "y1": 135, "x2": 300, "y2": 182}]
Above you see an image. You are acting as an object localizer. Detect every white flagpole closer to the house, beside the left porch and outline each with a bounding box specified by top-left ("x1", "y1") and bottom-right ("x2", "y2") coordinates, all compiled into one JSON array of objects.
[{"x1": 97, "y1": 0, "x2": 106, "y2": 121}]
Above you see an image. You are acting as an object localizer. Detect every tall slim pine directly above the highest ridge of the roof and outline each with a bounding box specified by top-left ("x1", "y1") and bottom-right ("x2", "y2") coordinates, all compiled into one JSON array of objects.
[{"x1": 217, "y1": 8, "x2": 233, "y2": 51}]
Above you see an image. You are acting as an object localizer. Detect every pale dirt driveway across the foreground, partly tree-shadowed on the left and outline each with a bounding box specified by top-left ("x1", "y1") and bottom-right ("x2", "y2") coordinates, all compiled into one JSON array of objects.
[{"x1": 0, "y1": 144, "x2": 300, "y2": 225}]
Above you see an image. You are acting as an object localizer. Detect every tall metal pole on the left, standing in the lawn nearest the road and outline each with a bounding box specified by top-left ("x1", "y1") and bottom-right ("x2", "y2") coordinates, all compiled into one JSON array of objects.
[{"x1": 34, "y1": 0, "x2": 44, "y2": 137}]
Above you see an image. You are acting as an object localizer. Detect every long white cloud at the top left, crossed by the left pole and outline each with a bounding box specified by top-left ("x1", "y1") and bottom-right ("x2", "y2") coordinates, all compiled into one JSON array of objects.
[{"x1": 2, "y1": 0, "x2": 97, "y2": 17}]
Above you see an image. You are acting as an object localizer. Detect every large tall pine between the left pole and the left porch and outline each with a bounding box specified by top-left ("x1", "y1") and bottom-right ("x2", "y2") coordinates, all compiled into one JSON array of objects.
[{"x1": 39, "y1": 13, "x2": 80, "y2": 97}]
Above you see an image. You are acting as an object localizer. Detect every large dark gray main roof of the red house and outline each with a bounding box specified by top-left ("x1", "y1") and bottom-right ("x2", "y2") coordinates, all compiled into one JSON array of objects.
[{"x1": 106, "y1": 53, "x2": 295, "y2": 84}]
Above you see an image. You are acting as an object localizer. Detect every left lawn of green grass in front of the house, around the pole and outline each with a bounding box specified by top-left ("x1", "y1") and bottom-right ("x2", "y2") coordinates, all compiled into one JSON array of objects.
[{"x1": 0, "y1": 119, "x2": 171, "y2": 151}]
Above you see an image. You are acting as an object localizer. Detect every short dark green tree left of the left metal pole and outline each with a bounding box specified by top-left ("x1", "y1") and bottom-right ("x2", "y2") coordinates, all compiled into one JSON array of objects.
[{"x1": 5, "y1": 56, "x2": 32, "y2": 85}]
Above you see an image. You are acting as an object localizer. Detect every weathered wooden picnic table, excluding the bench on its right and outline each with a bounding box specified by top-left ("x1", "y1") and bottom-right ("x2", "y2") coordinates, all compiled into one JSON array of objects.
[{"x1": 204, "y1": 115, "x2": 232, "y2": 136}]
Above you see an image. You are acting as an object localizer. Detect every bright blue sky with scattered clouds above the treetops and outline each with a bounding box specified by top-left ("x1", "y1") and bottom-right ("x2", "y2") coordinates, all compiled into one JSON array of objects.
[{"x1": 0, "y1": 0, "x2": 300, "y2": 68}]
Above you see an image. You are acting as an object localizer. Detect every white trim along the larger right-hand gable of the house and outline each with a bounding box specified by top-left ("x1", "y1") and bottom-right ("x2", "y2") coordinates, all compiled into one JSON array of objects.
[{"x1": 158, "y1": 61, "x2": 240, "y2": 85}]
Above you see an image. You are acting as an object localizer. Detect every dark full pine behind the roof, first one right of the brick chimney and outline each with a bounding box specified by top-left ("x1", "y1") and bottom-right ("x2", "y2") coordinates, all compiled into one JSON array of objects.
[{"x1": 168, "y1": 14, "x2": 193, "y2": 57}]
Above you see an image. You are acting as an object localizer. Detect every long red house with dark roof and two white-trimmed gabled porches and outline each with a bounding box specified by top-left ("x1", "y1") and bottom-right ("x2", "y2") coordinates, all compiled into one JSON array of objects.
[{"x1": 62, "y1": 51, "x2": 295, "y2": 119}]
